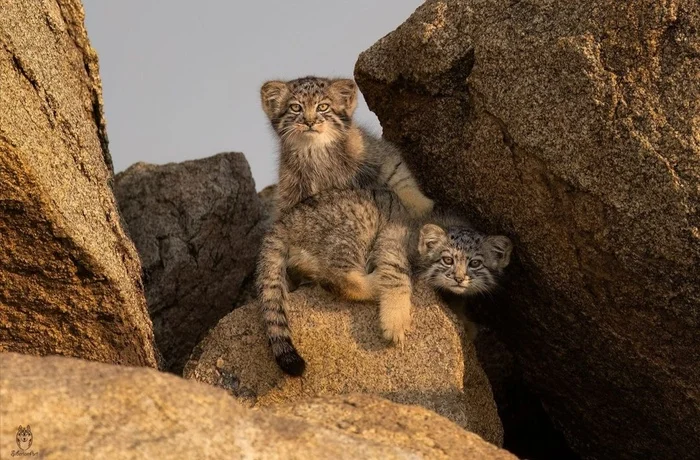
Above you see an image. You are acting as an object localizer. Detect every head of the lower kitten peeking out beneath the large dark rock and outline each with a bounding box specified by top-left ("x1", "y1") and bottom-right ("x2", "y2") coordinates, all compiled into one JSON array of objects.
[{"x1": 418, "y1": 224, "x2": 513, "y2": 295}]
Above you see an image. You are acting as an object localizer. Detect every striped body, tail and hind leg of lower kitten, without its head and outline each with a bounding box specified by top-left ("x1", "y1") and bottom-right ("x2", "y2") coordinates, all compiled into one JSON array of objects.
[{"x1": 257, "y1": 189, "x2": 416, "y2": 376}]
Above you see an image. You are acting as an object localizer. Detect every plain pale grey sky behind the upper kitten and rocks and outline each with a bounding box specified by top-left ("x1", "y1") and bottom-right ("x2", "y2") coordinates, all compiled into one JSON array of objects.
[{"x1": 83, "y1": 0, "x2": 422, "y2": 190}]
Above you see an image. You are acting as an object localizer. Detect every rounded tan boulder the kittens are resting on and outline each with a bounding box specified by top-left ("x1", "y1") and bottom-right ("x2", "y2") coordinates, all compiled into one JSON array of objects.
[{"x1": 185, "y1": 285, "x2": 503, "y2": 445}]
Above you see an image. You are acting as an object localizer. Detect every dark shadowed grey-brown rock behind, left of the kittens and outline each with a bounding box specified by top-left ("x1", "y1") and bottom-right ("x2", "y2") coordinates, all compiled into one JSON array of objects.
[{"x1": 114, "y1": 153, "x2": 265, "y2": 373}]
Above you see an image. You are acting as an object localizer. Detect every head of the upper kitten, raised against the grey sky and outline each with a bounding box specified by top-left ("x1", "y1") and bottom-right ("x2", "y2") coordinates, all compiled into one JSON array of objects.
[{"x1": 260, "y1": 77, "x2": 357, "y2": 146}]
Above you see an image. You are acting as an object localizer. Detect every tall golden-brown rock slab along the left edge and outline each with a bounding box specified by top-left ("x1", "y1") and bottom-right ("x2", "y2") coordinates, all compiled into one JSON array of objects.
[{"x1": 0, "y1": 0, "x2": 156, "y2": 366}]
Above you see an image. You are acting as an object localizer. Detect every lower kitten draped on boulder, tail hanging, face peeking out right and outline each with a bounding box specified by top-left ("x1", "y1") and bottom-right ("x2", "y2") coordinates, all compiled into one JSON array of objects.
[{"x1": 257, "y1": 189, "x2": 511, "y2": 376}]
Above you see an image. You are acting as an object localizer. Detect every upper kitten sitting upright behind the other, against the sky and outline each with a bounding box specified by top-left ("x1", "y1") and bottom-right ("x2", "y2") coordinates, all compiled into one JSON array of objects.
[{"x1": 260, "y1": 77, "x2": 433, "y2": 216}]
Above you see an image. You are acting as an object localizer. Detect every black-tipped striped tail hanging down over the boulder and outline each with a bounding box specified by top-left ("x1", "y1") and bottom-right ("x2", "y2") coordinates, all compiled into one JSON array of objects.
[{"x1": 257, "y1": 225, "x2": 306, "y2": 377}]
